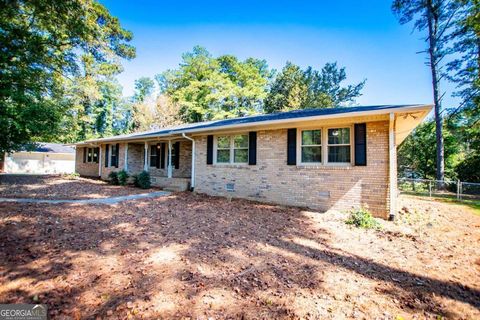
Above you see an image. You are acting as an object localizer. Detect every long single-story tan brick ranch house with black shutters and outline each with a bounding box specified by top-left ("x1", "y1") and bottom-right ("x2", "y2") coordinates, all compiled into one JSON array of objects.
[{"x1": 76, "y1": 105, "x2": 432, "y2": 218}]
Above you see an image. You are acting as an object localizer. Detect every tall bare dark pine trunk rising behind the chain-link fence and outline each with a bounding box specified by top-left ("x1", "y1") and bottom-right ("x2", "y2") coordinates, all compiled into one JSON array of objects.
[{"x1": 426, "y1": 0, "x2": 445, "y2": 180}]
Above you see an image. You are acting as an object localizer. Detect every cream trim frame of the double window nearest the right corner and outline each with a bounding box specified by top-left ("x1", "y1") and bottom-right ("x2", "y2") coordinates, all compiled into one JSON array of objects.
[{"x1": 297, "y1": 124, "x2": 354, "y2": 167}]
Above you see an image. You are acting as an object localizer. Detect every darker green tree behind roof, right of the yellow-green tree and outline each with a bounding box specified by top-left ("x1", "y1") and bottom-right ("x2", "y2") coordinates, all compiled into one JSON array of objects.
[{"x1": 265, "y1": 62, "x2": 365, "y2": 113}]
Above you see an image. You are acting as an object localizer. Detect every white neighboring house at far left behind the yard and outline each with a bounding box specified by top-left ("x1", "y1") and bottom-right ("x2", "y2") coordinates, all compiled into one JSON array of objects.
[{"x1": 0, "y1": 142, "x2": 75, "y2": 174}]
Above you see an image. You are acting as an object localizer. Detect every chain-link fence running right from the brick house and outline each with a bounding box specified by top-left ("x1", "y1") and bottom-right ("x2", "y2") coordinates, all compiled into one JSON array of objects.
[{"x1": 398, "y1": 178, "x2": 480, "y2": 200}]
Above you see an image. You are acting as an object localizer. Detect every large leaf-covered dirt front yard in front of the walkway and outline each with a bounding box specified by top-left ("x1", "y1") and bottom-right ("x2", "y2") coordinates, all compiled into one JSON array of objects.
[{"x1": 0, "y1": 176, "x2": 480, "y2": 319}]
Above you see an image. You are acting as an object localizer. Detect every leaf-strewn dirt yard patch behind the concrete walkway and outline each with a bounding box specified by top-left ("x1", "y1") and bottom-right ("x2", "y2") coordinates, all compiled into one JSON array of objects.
[{"x1": 0, "y1": 174, "x2": 152, "y2": 200}]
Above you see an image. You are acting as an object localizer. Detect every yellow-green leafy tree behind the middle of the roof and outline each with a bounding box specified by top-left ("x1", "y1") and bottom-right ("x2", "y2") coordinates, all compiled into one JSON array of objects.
[{"x1": 156, "y1": 46, "x2": 270, "y2": 122}]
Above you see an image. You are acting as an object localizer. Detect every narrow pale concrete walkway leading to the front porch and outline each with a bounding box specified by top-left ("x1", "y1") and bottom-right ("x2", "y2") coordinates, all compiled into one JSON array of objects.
[{"x1": 0, "y1": 191, "x2": 171, "y2": 204}]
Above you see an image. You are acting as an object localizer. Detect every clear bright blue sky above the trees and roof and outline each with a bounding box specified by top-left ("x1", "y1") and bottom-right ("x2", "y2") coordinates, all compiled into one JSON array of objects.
[{"x1": 100, "y1": 0, "x2": 456, "y2": 107}]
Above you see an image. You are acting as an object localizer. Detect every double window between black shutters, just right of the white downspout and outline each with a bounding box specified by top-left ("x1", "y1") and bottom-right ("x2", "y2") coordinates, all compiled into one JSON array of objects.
[{"x1": 216, "y1": 134, "x2": 248, "y2": 163}]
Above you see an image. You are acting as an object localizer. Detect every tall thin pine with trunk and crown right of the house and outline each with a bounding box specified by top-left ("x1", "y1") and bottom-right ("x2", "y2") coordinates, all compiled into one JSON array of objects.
[{"x1": 392, "y1": 0, "x2": 457, "y2": 180}]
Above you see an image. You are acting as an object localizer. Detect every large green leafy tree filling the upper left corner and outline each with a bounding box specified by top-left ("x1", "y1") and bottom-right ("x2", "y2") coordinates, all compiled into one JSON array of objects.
[{"x1": 0, "y1": 0, "x2": 135, "y2": 152}]
